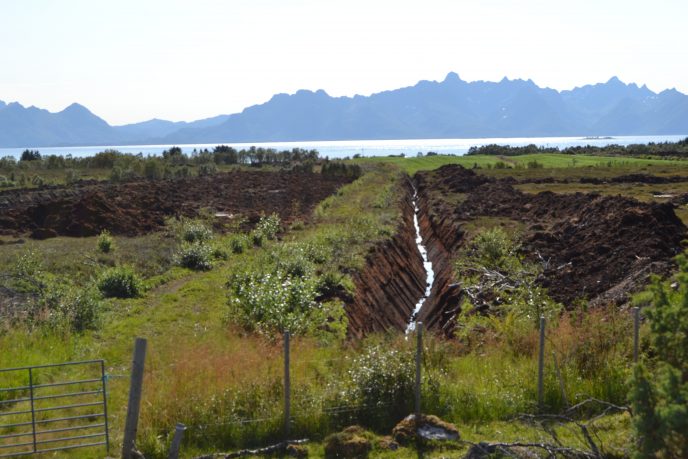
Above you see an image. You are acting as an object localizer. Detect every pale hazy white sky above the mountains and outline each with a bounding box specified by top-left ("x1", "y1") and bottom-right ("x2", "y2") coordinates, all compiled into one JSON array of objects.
[{"x1": 0, "y1": 0, "x2": 688, "y2": 124}]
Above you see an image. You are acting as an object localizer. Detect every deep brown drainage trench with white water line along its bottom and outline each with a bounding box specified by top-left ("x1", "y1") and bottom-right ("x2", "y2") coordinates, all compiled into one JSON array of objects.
[{"x1": 346, "y1": 179, "x2": 462, "y2": 338}]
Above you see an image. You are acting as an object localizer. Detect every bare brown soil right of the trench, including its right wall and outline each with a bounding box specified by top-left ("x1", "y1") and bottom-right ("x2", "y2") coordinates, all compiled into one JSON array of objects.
[{"x1": 415, "y1": 166, "x2": 686, "y2": 333}]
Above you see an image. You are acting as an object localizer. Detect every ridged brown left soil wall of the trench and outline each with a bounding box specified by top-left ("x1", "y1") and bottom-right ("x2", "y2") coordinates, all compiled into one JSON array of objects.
[{"x1": 346, "y1": 183, "x2": 426, "y2": 338}]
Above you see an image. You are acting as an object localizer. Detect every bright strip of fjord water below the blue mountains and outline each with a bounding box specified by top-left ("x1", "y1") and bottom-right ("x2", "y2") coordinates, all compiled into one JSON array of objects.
[{"x1": 0, "y1": 134, "x2": 688, "y2": 159}]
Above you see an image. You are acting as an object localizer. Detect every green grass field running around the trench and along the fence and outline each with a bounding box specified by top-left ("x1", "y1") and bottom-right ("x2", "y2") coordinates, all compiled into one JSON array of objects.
[{"x1": 0, "y1": 155, "x2": 688, "y2": 458}]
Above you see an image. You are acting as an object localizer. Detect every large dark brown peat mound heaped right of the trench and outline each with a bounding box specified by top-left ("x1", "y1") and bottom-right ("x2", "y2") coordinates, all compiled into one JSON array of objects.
[{"x1": 455, "y1": 183, "x2": 686, "y2": 304}]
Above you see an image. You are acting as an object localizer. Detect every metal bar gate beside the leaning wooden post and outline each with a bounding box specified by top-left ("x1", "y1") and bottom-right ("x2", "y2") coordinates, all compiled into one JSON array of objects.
[{"x1": 0, "y1": 360, "x2": 110, "y2": 458}]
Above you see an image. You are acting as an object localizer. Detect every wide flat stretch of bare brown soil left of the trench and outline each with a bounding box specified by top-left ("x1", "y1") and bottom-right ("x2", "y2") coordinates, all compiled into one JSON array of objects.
[{"x1": 0, "y1": 171, "x2": 350, "y2": 239}]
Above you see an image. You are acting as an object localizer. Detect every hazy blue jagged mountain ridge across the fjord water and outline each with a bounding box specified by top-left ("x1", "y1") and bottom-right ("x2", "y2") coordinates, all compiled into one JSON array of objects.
[{"x1": 0, "y1": 72, "x2": 688, "y2": 148}]
